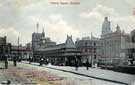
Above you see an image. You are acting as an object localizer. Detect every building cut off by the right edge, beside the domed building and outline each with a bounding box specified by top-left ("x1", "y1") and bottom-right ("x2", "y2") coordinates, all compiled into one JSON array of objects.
[{"x1": 122, "y1": 30, "x2": 135, "y2": 66}]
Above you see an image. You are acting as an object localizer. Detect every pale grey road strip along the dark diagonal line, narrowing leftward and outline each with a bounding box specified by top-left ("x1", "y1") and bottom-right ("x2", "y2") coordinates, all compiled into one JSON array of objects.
[{"x1": 23, "y1": 61, "x2": 135, "y2": 85}]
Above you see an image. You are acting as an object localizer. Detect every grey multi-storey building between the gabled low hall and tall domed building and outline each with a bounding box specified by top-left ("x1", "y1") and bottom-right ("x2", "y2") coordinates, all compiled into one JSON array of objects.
[{"x1": 75, "y1": 37, "x2": 101, "y2": 65}]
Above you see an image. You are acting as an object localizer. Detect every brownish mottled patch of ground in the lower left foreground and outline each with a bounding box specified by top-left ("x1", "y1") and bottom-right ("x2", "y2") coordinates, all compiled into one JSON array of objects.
[{"x1": 0, "y1": 61, "x2": 65, "y2": 85}]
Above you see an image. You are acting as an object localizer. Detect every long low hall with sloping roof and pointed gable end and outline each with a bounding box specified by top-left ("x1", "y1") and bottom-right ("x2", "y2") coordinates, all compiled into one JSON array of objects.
[{"x1": 34, "y1": 36, "x2": 81, "y2": 66}]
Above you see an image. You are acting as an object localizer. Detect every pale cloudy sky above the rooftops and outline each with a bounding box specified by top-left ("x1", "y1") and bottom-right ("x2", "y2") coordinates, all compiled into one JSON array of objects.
[{"x1": 0, "y1": 0, "x2": 135, "y2": 45}]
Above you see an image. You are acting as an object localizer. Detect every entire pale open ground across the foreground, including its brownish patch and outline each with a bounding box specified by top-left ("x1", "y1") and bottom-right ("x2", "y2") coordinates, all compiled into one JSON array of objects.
[{"x1": 0, "y1": 61, "x2": 135, "y2": 85}]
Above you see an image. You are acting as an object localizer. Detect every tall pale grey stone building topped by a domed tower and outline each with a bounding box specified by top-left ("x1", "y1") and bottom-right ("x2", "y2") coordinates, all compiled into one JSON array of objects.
[{"x1": 99, "y1": 17, "x2": 130, "y2": 65}]
